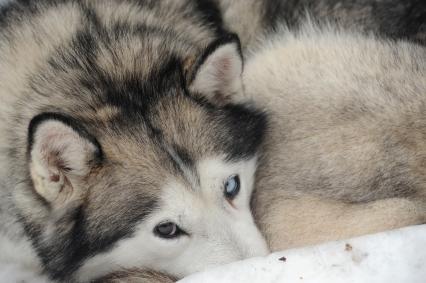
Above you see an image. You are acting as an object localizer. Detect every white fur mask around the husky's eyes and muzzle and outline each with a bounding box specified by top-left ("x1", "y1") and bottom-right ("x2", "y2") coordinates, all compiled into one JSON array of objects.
[{"x1": 80, "y1": 158, "x2": 267, "y2": 279}]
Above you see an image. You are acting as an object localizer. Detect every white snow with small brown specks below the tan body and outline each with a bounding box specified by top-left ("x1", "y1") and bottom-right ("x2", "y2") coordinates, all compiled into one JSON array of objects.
[{"x1": 179, "y1": 225, "x2": 426, "y2": 283}]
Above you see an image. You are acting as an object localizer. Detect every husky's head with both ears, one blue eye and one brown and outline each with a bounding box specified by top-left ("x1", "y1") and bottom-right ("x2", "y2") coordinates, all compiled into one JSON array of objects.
[{"x1": 28, "y1": 37, "x2": 267, "y2": 281}]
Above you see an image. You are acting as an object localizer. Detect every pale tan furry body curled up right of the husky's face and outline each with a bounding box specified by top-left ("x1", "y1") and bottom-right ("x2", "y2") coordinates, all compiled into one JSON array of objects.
[{"x1": 243, "y1": 23, "x2": 426, "y2": 250}]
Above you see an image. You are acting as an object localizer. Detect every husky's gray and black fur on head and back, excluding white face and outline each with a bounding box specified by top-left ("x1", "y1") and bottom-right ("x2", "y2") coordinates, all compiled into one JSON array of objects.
[{"x1": 0, "y1": 0, "x2": 265, "y2": 281}]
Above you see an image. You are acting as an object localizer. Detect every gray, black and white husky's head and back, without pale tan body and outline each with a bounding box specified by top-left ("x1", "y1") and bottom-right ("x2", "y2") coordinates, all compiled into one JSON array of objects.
[{"x1": 0, "y1": 0, "x2": 267, "y2": 282}]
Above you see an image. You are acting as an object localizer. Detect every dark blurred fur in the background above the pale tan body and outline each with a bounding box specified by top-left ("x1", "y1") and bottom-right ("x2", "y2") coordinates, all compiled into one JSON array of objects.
[{"x1": 215, "y1": 0, "x2": 426, "y2": 47}]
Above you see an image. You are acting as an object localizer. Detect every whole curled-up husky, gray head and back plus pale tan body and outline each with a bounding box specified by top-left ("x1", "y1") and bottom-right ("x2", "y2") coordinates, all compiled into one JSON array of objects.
[{"x1": 0, "y1": 0, "x2": 426, "y2": 282}]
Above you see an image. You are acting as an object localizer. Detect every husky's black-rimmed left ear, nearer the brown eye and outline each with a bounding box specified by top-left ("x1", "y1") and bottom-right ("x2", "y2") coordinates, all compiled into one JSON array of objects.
[{"x1": 28, "y1": 113, "x2": 101, "y2": 206}]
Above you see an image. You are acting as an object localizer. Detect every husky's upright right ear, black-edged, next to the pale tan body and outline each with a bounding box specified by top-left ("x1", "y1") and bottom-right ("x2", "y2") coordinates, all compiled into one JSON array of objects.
[{"x1": 189, "y1": 34, "x2": 243, "y2": 104}]
